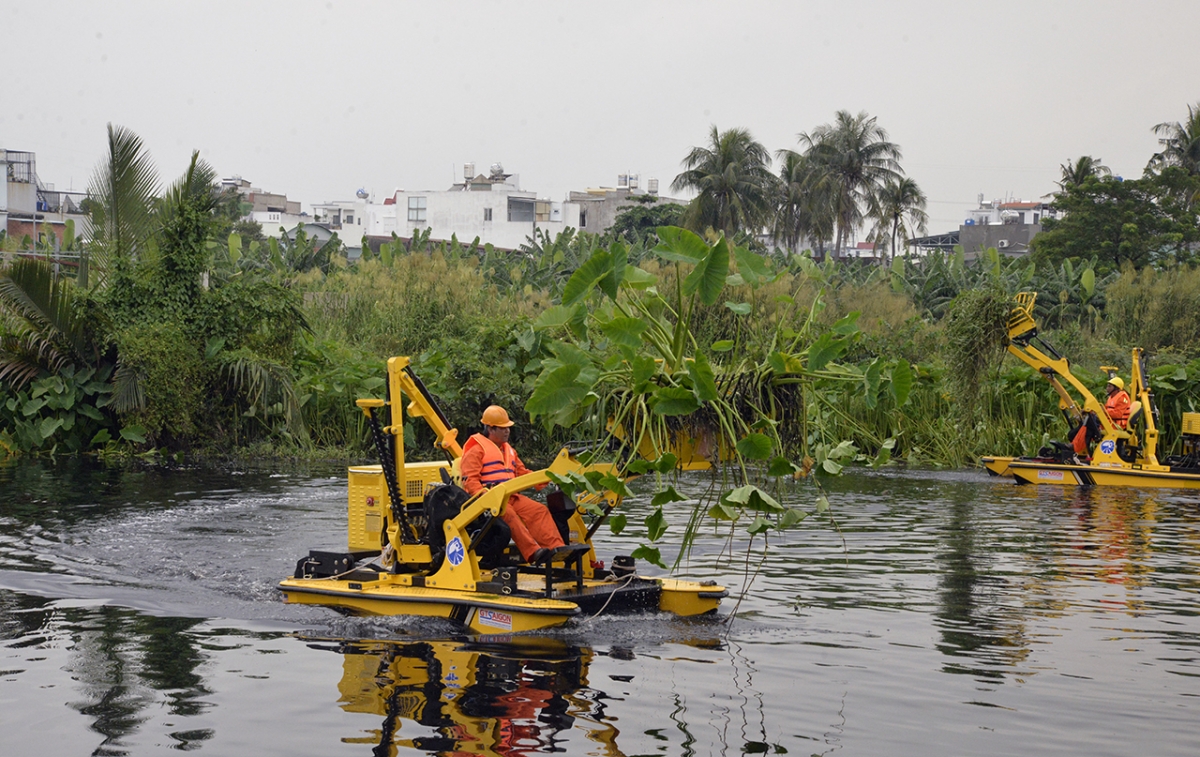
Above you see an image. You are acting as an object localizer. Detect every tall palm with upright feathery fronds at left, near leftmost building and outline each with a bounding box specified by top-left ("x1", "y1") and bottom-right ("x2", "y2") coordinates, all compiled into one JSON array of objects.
[{"x1": 88, "y1": 124, "x2": 158, "y2": 284}]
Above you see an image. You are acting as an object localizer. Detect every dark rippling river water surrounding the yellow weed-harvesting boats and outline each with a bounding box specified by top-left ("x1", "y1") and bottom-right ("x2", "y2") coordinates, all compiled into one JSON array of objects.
[{"x1": 0, "y1": 462, "x2": 1200, "y2": 756}]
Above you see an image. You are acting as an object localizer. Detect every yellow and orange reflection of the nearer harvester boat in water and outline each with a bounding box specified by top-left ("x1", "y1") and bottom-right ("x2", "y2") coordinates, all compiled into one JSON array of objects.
[{"x1": 304, "y1": 636, "x2": 622, "y2": 757}]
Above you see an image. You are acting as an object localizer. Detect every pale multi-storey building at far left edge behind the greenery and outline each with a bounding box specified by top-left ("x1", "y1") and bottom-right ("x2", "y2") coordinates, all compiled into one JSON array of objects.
[{"x1": 0, "y1": 149, "x2": 89, "y2": 250}]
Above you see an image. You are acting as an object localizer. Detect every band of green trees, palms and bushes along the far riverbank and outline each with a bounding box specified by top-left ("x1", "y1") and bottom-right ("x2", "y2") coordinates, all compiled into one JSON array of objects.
[{"x1": 0, "y1": 104, "x2": 1200, "y2": 462}]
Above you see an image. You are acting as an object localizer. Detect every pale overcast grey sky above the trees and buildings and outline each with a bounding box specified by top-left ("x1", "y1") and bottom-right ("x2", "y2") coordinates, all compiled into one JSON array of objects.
[{"x1": 7, "y1": 0, "x2": 1200, "y2": 232}]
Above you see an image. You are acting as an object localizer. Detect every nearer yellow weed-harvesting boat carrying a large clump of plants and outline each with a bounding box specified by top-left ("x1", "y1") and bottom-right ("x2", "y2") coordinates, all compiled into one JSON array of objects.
[{"x1": 280, "y1": 358, "x2": 728, "y2": 633}]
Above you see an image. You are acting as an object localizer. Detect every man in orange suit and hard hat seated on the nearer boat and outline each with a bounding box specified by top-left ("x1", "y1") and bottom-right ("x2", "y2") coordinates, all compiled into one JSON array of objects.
[{"x1": 458, "y1": 404, "x2": 564, "y2": 564}]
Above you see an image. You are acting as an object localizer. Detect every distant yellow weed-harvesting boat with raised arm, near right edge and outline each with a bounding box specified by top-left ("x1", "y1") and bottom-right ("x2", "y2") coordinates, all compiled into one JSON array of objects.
[{"x1": 982, "y1": 292, "x2": 1200, "y2": 488}]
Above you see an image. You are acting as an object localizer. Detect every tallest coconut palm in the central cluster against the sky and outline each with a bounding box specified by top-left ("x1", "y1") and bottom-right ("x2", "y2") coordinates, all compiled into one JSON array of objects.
[{"x1": 798, "y1": 110, "x2": 904, "y2": 257}]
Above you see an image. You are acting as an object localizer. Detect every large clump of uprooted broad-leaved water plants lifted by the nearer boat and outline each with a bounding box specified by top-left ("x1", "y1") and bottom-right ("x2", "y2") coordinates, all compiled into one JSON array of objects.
[{"x1": 522, "y1": 227, "x2": 912, "y2": 565}]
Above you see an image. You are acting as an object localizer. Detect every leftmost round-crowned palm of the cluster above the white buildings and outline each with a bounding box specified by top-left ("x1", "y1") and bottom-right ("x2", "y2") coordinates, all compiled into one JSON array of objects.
[{"x1": 671, "y1": 125, "x2": 775, "y2": 236}]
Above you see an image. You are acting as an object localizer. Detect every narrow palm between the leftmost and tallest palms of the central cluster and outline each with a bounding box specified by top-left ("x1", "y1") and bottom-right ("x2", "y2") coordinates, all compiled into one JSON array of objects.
[{"x1": 772, "y1": 150, "x2": 836, "y2": 258}]
